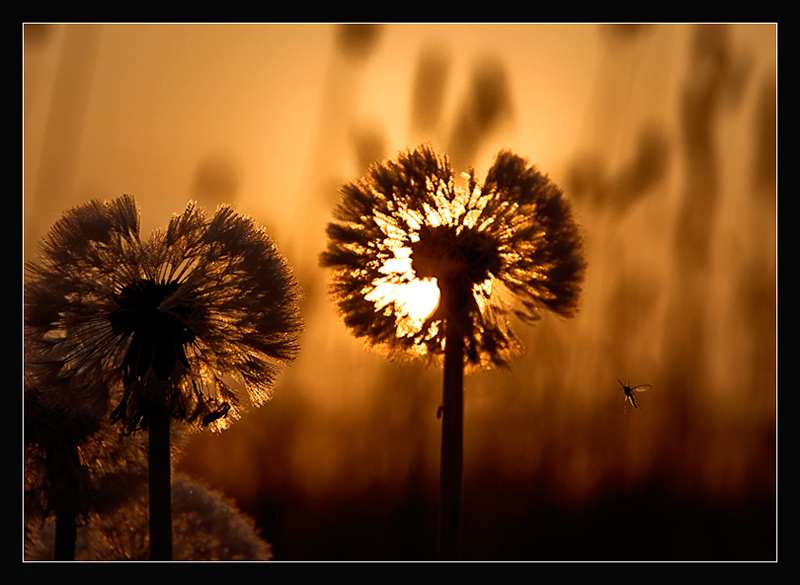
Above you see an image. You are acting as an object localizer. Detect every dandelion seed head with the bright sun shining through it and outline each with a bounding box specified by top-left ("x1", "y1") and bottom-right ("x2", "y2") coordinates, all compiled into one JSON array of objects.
[{"x1": 321, "y1": 145, "x2": 585, "y2": 367}]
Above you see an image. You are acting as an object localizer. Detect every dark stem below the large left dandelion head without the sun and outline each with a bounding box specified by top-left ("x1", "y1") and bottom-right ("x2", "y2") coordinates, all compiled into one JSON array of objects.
[{"x1": 148, "y1": 409, "x2": 172, "y2": 561}]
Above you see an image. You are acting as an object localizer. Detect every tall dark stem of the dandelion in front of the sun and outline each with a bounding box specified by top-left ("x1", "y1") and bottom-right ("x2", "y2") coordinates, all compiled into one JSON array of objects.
[{"x1": 437, "y1": 283, "x2": 464, "y2": 560}]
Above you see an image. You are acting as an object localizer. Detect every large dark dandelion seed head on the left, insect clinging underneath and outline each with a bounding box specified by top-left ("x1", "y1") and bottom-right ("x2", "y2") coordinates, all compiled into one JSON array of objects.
[{"x1": 25, "y1": 196, "x2": 302, "y2": 431}]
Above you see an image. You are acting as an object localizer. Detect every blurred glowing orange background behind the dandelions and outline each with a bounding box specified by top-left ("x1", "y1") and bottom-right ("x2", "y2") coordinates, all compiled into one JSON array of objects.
[{"x1": 24, "y1": 24, "x2": 777, "y2": 560}]
